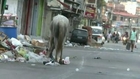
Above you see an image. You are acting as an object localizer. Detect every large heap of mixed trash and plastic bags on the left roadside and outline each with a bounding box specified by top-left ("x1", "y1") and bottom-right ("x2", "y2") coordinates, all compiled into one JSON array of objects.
[{"x1": 0, "y1": 32, "x2": 47, "y2": 63}]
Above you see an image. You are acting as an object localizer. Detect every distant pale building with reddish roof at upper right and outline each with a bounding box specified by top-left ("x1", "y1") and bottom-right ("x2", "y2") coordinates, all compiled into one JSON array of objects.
[{"x1": 107, "y1": 1, "x2": 139, "y2": 33}]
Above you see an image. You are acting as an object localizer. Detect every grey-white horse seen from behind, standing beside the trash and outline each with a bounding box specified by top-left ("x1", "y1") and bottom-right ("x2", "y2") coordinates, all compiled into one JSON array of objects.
[{"x1": 47, "y1": 14, "x2": 70, "y2": 64}]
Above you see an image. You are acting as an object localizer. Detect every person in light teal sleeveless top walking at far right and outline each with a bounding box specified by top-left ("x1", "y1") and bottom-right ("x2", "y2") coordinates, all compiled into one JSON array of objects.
[{"x1": 129, "y1": 28, "x2": 138, "y2": 52}]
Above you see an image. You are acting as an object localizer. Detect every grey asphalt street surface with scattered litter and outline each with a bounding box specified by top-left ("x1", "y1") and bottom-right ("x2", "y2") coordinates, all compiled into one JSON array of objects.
[{"x1": 0, "y1": 43, "x2": 140, "y2": 79}]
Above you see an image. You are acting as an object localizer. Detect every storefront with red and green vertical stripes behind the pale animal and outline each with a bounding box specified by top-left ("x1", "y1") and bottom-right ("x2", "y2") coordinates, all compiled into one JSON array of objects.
[{"x1": 17, "y1": 0, "x2": 84, "y2": 39}]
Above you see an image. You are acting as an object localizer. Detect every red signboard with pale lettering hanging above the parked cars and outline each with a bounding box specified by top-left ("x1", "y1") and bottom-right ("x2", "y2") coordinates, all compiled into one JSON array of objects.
[{"x1": 84, "y1": 5, "x2": 95, "y2": 18}]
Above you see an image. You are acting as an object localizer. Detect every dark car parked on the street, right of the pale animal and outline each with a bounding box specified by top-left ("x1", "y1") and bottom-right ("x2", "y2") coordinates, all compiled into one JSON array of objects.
[{"x1": 70, "y1": 29, "x2": 88, "y2": 44}]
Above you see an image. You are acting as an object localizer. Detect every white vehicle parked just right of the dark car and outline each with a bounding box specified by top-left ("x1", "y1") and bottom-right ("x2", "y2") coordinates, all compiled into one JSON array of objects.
[{"x1": 91, "y1": 26, "x2": 105, "y2": 45}]
